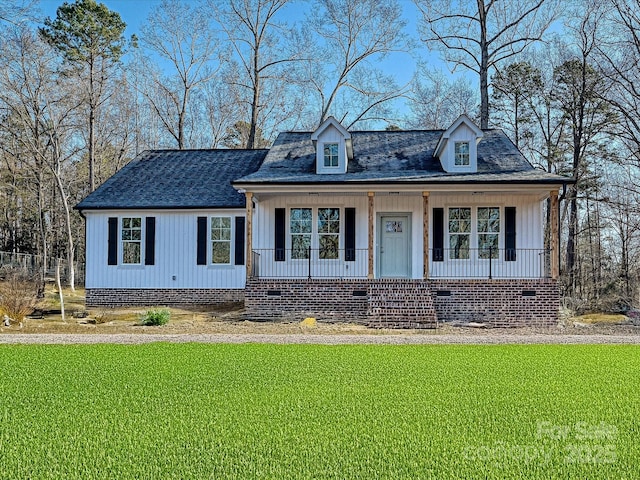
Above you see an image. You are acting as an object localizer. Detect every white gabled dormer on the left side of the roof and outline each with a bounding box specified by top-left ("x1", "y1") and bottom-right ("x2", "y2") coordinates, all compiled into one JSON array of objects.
[{"x1": 311, "y1": 117, "x2": 353, "y2": 174}]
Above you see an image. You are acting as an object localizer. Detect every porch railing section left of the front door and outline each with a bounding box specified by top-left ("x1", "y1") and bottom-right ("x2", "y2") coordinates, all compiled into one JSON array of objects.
[{"x1": 251, "y1": 248, "x2": 369, "y2": 278}]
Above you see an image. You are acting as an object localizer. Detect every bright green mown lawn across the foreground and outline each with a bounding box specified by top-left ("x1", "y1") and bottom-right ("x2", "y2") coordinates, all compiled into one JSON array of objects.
[{"x1": 0, "y1": 344, "x2": 640, "y2": 479}]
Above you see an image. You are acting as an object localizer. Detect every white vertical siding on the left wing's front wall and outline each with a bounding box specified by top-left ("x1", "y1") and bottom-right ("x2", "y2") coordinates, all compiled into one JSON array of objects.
[{"x1": 84, "y1": 209, "x2": 246, "y2": 289}]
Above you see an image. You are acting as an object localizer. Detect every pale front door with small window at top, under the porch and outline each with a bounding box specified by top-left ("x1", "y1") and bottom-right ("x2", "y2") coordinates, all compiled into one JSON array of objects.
[{"x1": 378, "y1": 215, "x2": 411, "y2": 278}]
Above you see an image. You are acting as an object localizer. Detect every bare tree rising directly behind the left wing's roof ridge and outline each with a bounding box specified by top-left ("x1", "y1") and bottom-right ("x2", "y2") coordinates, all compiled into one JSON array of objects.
[{"x1": 141, "y1": 0, "x2": 221, "y2": 149}]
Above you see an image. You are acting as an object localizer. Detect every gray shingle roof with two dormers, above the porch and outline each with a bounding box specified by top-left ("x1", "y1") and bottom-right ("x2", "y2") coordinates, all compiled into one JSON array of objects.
[{"x1": 236, "y1": 129, "x2": 570, "y2": 184}]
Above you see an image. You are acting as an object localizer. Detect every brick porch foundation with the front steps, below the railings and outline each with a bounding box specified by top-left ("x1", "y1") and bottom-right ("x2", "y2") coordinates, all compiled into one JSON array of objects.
[{"x1": 245, "y1": 279, "x2": 560, "y2": 328}]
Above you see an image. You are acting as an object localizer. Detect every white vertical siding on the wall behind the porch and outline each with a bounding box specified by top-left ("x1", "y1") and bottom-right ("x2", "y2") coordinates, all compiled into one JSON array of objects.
[{"x1": 253, "y1": 192, "x2": 544, "y2": 279}]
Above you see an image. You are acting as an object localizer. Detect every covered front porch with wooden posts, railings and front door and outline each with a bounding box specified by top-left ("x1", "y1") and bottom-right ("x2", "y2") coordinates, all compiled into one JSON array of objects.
[{"x1": 246, "y1": 187, "x2": 559, "y2": 280}]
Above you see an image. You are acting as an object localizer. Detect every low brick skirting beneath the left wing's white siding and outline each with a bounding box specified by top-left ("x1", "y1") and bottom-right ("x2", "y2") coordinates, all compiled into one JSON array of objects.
[{"x1": 85, "y1": 288, "x2": 244, "y2": 308}]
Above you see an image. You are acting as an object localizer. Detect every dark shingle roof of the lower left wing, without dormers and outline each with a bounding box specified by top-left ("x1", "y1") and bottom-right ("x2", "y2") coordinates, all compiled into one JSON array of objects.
[{"x1": 75, "y1": 150, "x2": 267, "y2": 210}]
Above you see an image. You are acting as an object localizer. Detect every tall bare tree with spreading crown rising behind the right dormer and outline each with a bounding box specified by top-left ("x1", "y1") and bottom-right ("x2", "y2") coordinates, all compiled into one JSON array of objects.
[{"x1": 413, "y1": 0, "x2": 557, "y2": 129}]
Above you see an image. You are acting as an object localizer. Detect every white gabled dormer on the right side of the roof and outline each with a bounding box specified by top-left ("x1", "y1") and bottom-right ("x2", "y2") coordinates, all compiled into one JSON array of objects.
[{"x1": 435, "y1": 114, "x2": 482, "y2": 173}]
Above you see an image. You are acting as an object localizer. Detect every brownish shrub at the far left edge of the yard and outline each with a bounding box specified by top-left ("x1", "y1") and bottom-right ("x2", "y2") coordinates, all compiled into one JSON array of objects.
[{"x1": 0, "y1": 267, "x2": 38, "y2": 322}]
